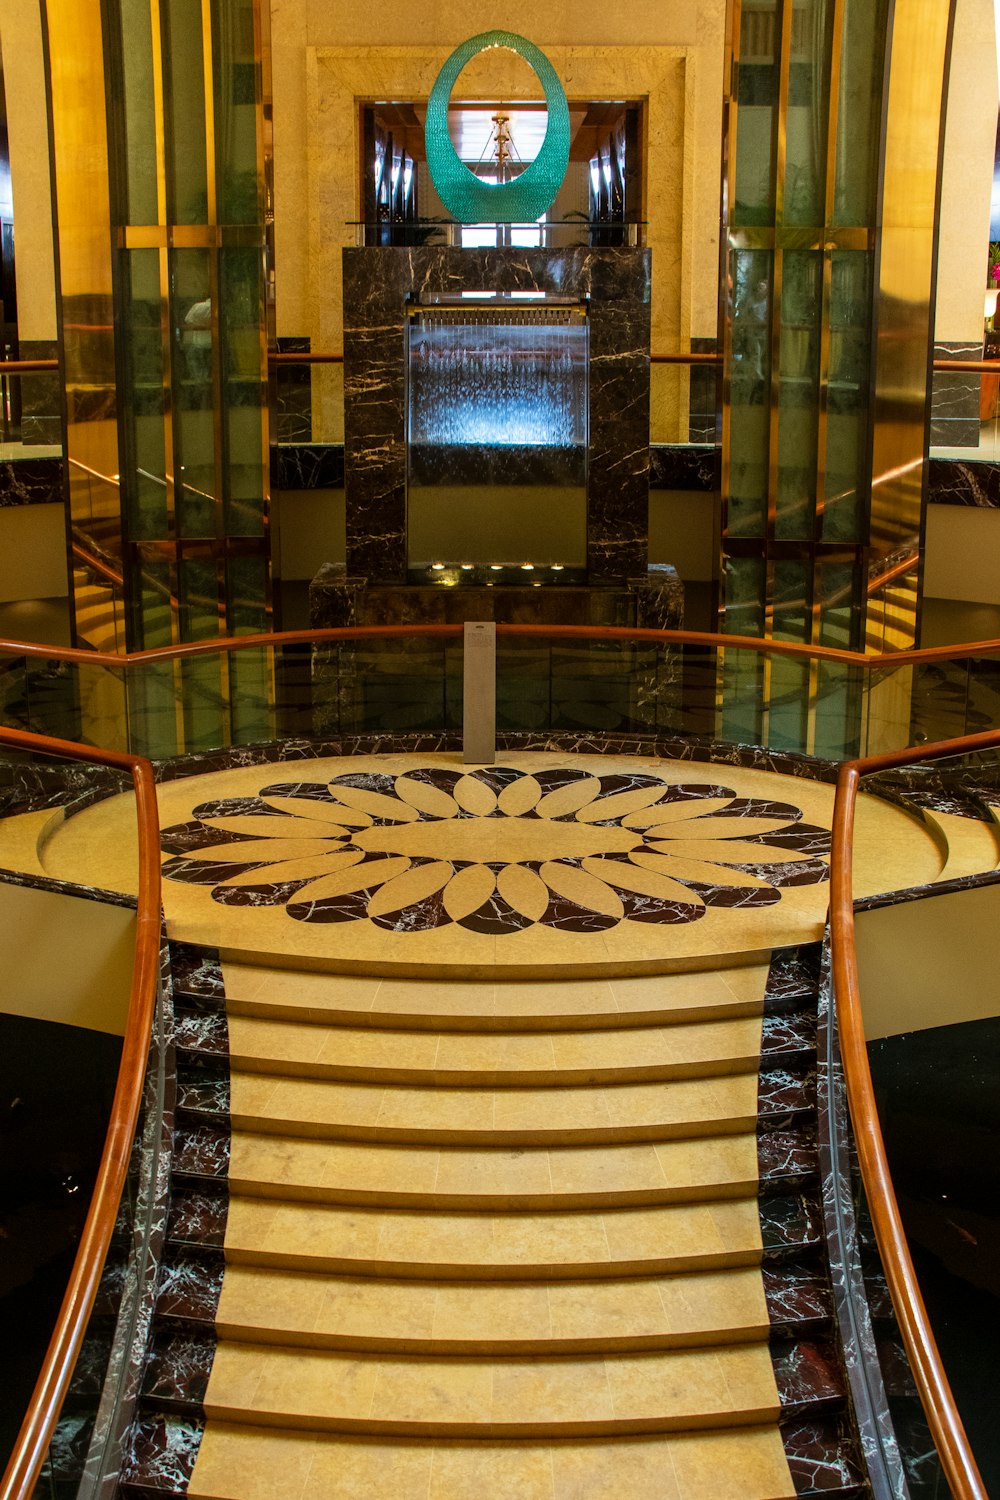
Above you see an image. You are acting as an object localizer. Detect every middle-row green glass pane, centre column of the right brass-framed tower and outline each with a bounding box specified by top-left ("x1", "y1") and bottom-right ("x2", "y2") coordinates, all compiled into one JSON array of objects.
[{"x1": 775, "y1": 251, "x2": 823, "y2": 539}]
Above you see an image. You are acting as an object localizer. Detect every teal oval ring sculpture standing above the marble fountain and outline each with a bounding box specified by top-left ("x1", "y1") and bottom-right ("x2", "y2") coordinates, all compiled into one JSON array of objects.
[{"x1": 424, "y1": 32, "x2": 570, "y2": 224}]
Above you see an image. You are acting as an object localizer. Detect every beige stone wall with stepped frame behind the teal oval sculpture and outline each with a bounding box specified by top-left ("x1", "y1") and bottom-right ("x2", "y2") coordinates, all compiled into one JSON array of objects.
[{"x1": 271, "y1": 0, "x2": 726, "y2": 438}]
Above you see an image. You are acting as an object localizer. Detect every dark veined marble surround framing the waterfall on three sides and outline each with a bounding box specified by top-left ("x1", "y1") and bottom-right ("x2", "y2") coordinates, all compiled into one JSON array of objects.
[{"x1": 343, "y1": 246, "x2": 651, "y2": 584}]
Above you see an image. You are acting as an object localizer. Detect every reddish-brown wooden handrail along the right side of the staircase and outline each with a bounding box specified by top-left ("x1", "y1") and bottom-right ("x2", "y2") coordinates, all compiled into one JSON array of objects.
[{"x1": 831, "y1": 731, "x2": 1000, "y2": 1500}]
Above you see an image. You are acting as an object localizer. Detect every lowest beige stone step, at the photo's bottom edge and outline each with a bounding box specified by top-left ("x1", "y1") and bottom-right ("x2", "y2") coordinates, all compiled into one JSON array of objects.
[{"x1": 187, "y1": 1422, "x2": 796, "y2": 1500}]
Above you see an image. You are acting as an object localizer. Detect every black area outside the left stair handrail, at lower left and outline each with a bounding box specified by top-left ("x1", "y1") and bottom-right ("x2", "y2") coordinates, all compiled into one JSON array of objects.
[{"x1": 0, "y1": 1016, "x2": 121, "y2": 1470}]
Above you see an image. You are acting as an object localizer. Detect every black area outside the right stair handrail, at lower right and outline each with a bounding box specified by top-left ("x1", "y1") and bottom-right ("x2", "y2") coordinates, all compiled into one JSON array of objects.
[{"x1": 868, "y1": 1019, "x2": 1000, "y2": 1496}]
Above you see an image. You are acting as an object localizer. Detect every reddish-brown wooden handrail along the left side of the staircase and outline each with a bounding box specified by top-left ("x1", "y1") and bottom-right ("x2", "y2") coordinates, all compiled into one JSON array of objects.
[{"x1": 0, "y1": 729, "x2": 160, "y2": 1500}]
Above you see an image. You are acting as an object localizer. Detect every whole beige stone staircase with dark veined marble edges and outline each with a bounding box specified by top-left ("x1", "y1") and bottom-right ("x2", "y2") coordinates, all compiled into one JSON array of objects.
[{"x1": 119, "y1": 947, "x2": 862, "y2": 1500}]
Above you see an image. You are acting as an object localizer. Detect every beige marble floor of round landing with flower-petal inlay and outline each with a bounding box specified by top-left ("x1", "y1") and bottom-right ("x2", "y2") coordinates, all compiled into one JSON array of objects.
[{"x1": 25, "y1": 752, "x2": 946, "y2": 975}]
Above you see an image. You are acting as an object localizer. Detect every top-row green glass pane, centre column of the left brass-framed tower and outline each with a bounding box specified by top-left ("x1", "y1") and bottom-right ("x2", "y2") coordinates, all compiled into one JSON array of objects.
[{"x1": 163, "y1": 0, "x2": 214, "y2": 224}]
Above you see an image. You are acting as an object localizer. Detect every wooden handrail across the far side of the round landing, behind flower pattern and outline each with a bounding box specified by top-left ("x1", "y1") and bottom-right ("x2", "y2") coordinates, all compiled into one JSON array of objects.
[{"x1": 0, "y1": 624, "x2": 1000, "y2": 671}]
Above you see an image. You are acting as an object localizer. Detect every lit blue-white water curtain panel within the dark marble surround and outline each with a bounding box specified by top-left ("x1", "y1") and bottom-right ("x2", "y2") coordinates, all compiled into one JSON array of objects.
[{"x1": 406, "y1": 299, "x2": 588, "y2": 576}]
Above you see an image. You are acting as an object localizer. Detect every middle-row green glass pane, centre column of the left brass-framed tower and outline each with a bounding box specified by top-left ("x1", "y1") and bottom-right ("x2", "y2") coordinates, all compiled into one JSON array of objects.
[{"x1": 169, "y1": 251, "x2": 216, "y2": 540}]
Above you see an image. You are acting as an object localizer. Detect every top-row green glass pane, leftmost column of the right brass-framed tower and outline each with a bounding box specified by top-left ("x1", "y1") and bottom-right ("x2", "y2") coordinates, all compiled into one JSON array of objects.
[{"x1": 732, "y1": 0, "x2": 781, "y2": 225}]
